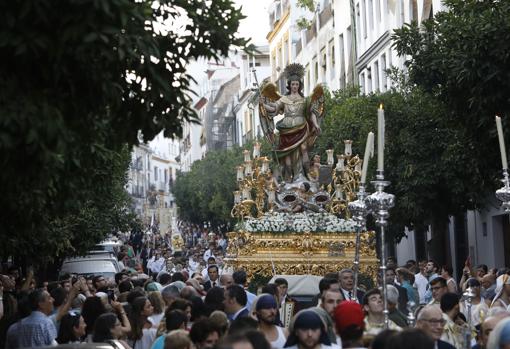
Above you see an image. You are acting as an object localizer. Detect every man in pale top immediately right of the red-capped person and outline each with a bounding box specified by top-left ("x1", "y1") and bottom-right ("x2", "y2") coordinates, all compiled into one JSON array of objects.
[{"x1": 363, "y1": 288, "x2": 402, "y2": 337}]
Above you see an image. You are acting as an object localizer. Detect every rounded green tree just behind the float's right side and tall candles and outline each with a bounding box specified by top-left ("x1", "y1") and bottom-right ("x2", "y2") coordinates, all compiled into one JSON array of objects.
[{"x1": 315, "y1": 85, "x2": 477, "y2": 260}]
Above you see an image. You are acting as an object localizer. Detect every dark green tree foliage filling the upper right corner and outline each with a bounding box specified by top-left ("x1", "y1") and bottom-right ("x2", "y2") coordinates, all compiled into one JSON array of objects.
[{"x1": 393, "y1": 0, "x2": 510, "y2": 205}]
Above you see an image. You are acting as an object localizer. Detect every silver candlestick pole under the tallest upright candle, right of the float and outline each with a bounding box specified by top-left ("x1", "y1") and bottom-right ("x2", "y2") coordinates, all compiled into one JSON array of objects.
[{"x1": 366, "y1": 170, "x2": 395, "y2": 329}]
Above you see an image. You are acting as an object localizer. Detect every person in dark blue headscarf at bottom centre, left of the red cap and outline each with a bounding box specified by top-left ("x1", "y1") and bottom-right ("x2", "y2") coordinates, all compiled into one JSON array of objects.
[{"x1": 284, "y1": 309, "x2": 331, "y2": 349}]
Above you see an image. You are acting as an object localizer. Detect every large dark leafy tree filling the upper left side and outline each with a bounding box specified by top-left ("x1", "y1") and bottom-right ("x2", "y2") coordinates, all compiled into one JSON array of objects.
[{"x1": 0, "y1": 0, "x2": 251, "y2": 260}]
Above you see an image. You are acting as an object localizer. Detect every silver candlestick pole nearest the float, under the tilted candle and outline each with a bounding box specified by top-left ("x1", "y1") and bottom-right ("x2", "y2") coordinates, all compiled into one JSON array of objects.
[{"x1": 348, "y1": 183, "x2": 369, "y2": 301}]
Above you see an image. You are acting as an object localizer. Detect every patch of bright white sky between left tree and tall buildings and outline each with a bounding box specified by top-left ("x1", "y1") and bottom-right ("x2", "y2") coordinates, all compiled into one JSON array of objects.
[{"x1": 234, "y1": 0, "x2": 273, "y2": 45}]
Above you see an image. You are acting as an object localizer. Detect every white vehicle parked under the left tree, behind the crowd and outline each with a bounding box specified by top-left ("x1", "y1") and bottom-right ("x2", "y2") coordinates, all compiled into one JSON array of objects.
[{"x1": 59, "y1": 254, "x2": 121, "y2": 279}]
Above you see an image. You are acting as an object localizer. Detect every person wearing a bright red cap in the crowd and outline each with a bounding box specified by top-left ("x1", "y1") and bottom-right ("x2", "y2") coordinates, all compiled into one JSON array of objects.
[{"x1": 334, "y1": 300, "x2": 365, "y2": 349}]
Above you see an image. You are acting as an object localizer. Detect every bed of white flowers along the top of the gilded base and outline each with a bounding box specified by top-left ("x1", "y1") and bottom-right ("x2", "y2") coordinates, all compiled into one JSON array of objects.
[{"x1": 238, "y1": 212, "x2": 356, "y2": 233}]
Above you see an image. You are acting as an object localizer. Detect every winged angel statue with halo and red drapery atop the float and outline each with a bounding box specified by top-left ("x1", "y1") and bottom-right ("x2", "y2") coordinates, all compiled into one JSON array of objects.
[{"x1": 259, "y1": 63, "x2": 325, "y2": 183}]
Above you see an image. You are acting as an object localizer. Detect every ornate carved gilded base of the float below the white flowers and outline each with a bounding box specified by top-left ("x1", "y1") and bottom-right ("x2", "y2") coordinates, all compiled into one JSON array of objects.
[{"x1": 225, "y1": 231, "x2": 379, "y2": 281}]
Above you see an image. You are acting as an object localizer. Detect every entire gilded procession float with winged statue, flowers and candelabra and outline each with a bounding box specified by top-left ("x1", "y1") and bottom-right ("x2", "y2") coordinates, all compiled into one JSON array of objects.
[{"x1": 225, "y1": 64, "x2": 393, "y2": 286}]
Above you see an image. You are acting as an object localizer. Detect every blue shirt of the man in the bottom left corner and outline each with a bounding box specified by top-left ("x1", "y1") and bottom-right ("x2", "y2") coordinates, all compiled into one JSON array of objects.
[{"x1": 6, "y1": 311, "x2": 57, "y2": 348}]
